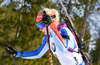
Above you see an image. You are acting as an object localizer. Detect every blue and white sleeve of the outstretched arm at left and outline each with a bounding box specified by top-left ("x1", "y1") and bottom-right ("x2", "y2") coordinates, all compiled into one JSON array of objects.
[{"x1": 16, "y1": 35, "x2": 48, "y2": 59}]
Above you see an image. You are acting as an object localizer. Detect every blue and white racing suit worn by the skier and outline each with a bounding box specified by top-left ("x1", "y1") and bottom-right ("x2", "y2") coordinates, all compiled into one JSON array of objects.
[{"x1": 16, "y1": 24, "x2": 85, "y2": 65}]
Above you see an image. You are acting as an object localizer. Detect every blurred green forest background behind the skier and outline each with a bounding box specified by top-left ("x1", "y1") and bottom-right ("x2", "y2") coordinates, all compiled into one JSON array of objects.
[{"x1": 0, "y1": 0, "x2": 100, "y2": 65}]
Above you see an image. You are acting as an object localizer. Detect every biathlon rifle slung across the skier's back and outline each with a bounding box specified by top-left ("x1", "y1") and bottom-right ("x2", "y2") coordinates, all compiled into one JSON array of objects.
[{"x1": 59, "y1": 0, "x2": 92, "y2": 65}]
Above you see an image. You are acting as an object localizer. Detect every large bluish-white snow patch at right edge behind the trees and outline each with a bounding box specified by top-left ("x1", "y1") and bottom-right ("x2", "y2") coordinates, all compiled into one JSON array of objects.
[{"x1": 88, "y1": 10, "x2": 100, "y2": 38}]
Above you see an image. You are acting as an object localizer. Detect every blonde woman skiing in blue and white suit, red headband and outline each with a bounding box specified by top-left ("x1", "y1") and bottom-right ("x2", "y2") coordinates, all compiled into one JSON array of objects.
[{"x1": 6, "y1": 8, "x2": 85, "y2": 65}]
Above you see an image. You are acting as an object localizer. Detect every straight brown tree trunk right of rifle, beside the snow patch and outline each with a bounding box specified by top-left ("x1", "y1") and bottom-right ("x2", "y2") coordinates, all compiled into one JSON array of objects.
[{"x1": 80, "y1": 0, "x2": 91, "y2": 39}]
